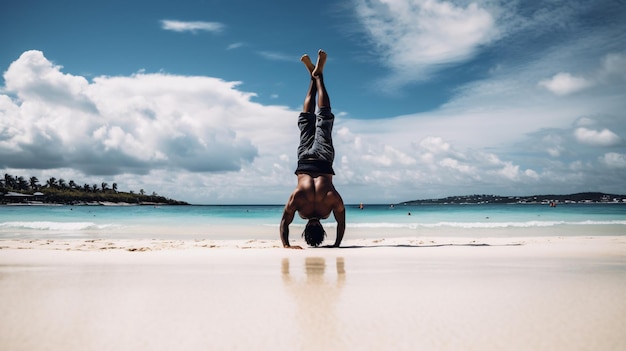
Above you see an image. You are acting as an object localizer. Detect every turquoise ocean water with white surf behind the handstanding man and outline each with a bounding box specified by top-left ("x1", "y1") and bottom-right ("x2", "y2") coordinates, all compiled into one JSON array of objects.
[{"x1": 0, "y1": 204, "x2": 626, "y2": 240}]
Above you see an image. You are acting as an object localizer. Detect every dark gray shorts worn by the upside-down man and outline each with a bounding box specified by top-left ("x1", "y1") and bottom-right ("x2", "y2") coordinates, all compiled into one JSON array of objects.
[{"x1": 296, "y1": 108, "x2": 335, "y2": 174}]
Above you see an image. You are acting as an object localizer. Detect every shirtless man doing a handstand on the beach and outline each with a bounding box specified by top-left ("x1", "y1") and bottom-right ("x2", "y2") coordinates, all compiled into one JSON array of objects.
[{"x1": 280, "y1": 50, "x2": 346, "y2": 249}]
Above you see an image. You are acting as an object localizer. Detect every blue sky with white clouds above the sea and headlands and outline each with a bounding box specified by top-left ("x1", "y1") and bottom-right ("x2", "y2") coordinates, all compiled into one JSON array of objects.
[{"x1": 0, "y1": 0, "x2": 626, "y2": 203}]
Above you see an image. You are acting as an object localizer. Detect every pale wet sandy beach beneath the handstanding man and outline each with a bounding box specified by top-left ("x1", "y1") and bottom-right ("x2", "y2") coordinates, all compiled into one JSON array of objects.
[{"x1": 0, "y1": 236, "x2": 626, "y2": 350}]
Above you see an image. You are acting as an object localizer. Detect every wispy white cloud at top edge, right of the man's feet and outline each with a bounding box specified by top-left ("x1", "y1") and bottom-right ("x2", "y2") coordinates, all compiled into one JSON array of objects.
[{"x1": 356, "y1": 0, "x2": 498, "y2": 82}]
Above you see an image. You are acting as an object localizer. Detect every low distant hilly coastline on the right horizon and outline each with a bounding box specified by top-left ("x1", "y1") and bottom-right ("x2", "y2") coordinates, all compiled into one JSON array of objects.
[{"x1": 400, "y1": 192, "x2": 626, "y2": 205}]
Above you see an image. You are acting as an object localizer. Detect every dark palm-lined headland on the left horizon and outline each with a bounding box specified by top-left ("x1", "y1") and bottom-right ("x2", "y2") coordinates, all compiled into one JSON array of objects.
[{"x1": 0, "y1": 173, "x2": 188, "y2": 205}]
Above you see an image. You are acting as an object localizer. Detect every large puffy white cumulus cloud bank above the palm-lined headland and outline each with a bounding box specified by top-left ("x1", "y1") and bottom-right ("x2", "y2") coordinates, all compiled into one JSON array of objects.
[{"x1": 0, "y1": 51, "x2": 290, "y2": 174}]
